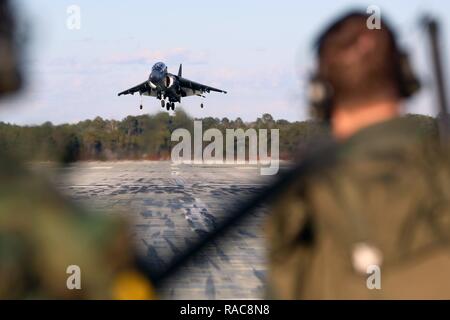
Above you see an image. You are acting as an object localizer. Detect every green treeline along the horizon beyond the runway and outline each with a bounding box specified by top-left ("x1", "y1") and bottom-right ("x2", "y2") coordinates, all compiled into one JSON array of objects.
[{"x1": 0, "y1": 109, "x2": 436, "y2": 162}]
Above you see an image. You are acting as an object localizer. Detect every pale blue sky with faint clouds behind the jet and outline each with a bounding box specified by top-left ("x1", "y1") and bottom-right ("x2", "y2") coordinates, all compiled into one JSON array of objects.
[{"x1": 0, "y1": 0, "x2": 450, "y2": 124}]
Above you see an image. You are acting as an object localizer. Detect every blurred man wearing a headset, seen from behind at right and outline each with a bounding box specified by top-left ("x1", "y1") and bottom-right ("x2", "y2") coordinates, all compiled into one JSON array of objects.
[{"x1": 267, "y1": 12, "x2": 450, "y2": 299}]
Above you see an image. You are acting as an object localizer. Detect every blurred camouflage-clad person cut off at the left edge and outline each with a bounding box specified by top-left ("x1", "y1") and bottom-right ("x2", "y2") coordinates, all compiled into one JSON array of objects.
[{"x1": 0, "y1": 0, "x2": 152, "y2": 299}]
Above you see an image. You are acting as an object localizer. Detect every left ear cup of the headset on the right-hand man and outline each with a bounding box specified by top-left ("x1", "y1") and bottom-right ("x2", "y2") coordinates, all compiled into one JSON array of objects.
[{"x1": 308, "y1": 75, "x2": 333, "y2": 121}]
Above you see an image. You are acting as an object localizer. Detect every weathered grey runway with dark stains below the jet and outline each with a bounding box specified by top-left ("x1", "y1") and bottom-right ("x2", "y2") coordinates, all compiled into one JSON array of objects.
[{"x1": 44, "y1": 161, "x2": 270, "y2": 299}]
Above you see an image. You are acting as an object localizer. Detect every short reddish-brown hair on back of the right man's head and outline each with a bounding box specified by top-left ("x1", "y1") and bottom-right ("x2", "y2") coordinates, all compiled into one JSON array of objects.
[{"x1": 317, "y1": 11, "x2": 401, "y2": 105}]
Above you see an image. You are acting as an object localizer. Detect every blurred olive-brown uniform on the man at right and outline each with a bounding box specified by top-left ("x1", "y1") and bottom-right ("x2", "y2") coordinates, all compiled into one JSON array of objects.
[{"x1": 267, "y1": 117, "x2": 450, "y2": 299}]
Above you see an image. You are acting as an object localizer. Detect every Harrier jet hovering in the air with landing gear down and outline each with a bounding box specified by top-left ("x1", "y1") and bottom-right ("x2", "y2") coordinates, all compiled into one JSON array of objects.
[{"x1": 118, "y1": 62, "x2": 227, "y2": 110}]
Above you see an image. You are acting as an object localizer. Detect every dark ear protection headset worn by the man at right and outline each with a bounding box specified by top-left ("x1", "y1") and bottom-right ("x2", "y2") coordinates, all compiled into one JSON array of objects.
[{"x1": 308, "y1": 14, "x2": 420, "y2": 122}]
